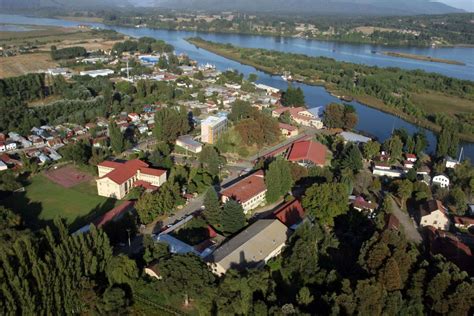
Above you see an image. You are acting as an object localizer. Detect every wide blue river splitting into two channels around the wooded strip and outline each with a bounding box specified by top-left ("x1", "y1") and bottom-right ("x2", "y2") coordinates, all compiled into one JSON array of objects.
[{"x1": 0, "y1": 14, "x2": 474, "y2": 161}]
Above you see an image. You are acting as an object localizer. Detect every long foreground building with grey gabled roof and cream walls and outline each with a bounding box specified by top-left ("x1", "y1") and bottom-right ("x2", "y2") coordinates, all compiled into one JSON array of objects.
[{"x1": 206, "y1": 219, "x2": 290, "y2": 275}]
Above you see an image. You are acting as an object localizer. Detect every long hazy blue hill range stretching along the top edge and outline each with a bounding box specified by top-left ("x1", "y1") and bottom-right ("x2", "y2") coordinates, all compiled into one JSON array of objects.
[{"x1": 0, "y1": 0, "x2": 464, "y2": 15}]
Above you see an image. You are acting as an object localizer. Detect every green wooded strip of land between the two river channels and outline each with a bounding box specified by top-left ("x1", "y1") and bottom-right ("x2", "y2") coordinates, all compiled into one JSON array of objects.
[{"x1": 189, "y1": 38, "x2": 474, "y2": 139}]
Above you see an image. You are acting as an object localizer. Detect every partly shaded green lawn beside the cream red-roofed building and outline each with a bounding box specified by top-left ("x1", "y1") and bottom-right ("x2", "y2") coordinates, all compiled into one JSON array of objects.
[{"x1": 3, "y1": 175, "x2": 117, "y2": 230}]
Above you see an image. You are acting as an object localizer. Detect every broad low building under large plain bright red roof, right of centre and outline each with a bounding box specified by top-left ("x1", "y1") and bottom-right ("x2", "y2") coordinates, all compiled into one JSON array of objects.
[{"x1": 287, "y1": 140, "x2": 327, "y2": 167}]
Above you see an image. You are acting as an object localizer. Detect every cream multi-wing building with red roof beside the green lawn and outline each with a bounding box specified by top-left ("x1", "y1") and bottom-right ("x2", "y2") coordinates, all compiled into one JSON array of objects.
[{"x1": 97, "y1": 159, "x2": 166, "y2": 199}]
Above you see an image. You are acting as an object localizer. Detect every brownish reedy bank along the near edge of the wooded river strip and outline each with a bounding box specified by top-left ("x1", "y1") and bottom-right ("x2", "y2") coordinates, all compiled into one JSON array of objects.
[{"x1": 186, "y1": 38, "x2": 474, "y2": 142}]
